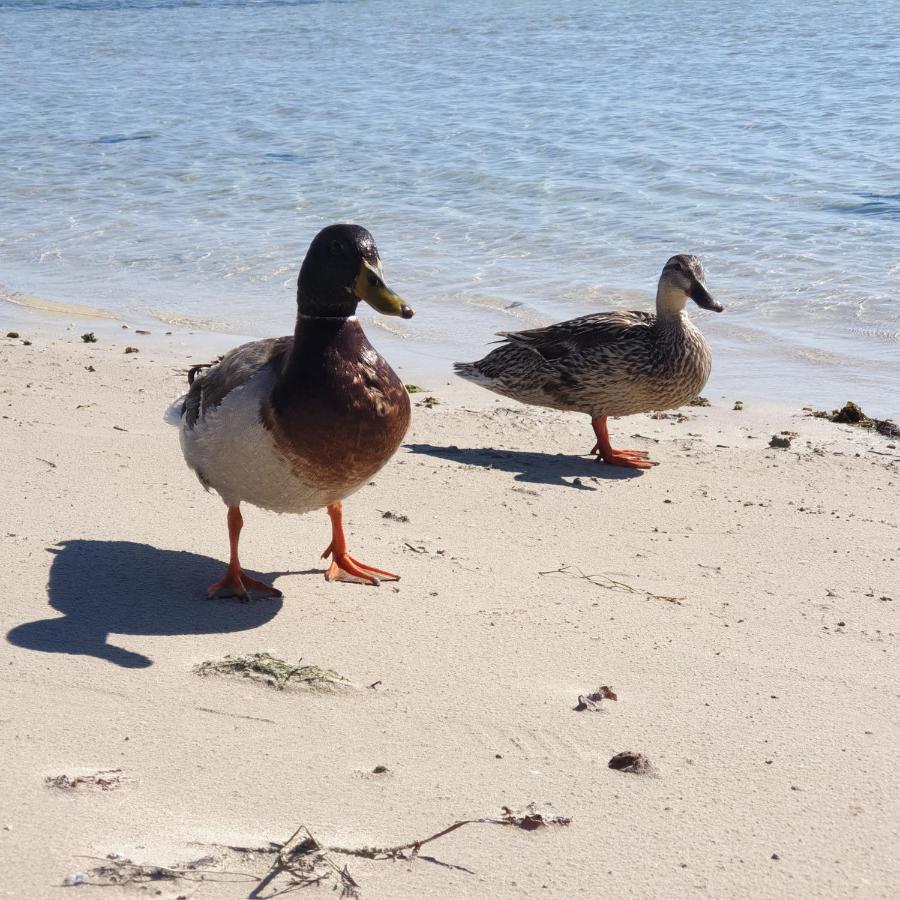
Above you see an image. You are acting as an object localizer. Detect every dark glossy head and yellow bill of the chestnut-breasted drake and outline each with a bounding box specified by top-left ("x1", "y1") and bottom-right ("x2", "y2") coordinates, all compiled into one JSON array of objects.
[{"x1": 297, "y1": 225, "x2": 413, "y2": 319}]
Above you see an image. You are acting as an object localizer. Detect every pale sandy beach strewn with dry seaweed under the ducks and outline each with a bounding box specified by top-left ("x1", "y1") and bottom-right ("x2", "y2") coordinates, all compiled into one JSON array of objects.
[{"x1": 0, "y1": 327, "x2": 900, "y2": 900}]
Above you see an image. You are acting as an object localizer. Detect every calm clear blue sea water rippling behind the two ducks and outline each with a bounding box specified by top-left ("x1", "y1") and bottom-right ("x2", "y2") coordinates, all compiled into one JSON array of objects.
[{"x1": 0, "y1": 0, "x2": 900, "y2": 415}]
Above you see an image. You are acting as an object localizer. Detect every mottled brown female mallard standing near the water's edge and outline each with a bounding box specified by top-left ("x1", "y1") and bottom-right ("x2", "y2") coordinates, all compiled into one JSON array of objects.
[{"x1": 454, "y1": 254, "x2": 723, "y2": 469}]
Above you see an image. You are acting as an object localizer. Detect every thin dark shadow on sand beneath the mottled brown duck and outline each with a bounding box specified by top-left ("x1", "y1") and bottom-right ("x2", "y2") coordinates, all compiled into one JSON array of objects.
[{"x1": 405, "y1": 444, "x2": 643, "y2": 491}]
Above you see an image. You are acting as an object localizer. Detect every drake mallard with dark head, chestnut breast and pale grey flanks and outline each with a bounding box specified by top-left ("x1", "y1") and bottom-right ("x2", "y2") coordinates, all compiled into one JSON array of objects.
[{"x1": 167, "y1": 225, "x2": 413, "y2": 597}]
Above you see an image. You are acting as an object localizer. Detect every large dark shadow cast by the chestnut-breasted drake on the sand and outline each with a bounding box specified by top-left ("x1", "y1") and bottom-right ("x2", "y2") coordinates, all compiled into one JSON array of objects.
[{"x1": 6, "y1": 541, "x2": 295, "y2": 668}]
